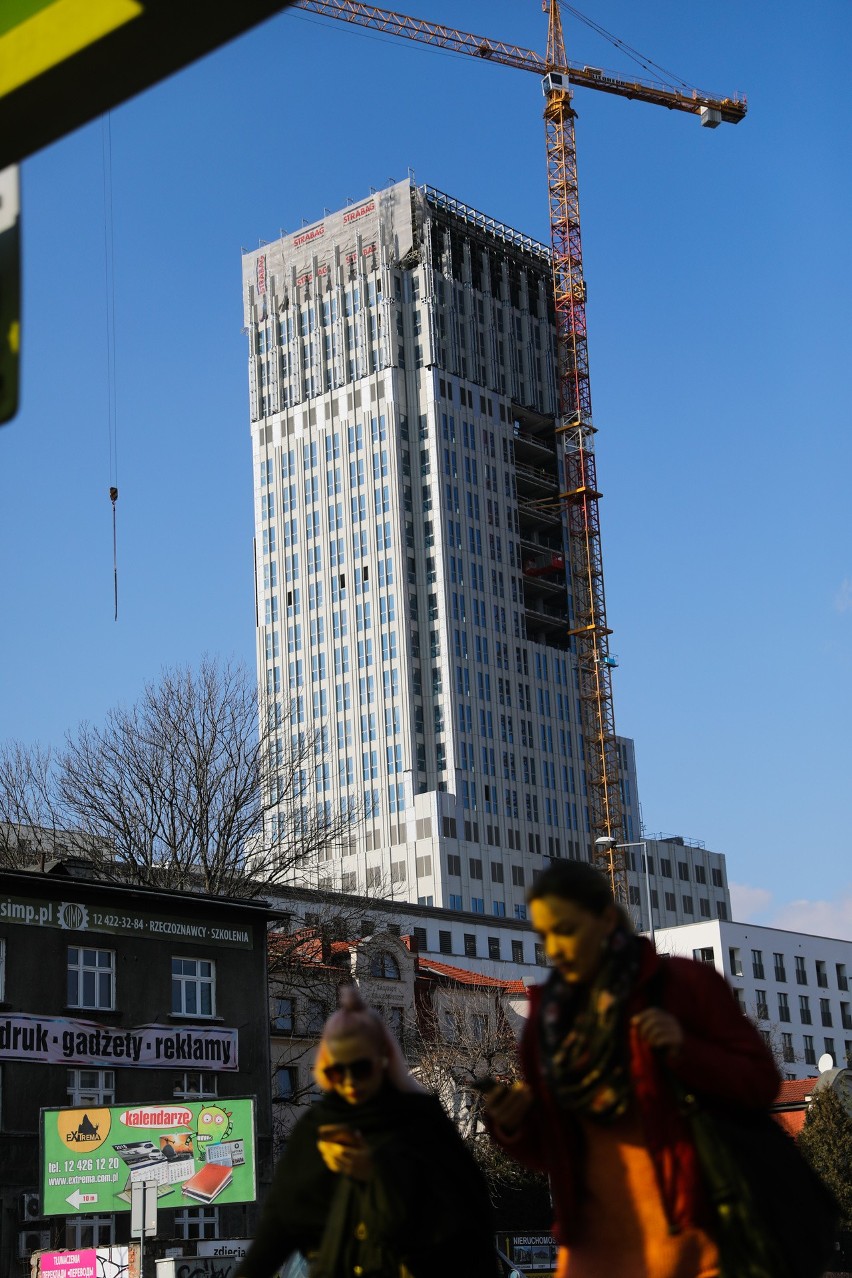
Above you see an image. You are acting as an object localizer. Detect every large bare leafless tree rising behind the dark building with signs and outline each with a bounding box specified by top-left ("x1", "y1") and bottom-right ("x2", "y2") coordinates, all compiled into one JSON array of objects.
[{"x1": 0, "y1": 658, "x2": 355, "y2": 896}]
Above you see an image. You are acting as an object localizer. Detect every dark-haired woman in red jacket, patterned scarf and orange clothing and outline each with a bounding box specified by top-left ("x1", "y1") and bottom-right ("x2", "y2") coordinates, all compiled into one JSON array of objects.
[{"x1": 487, "y1": 861, "x2": 779, "y2": 1278}]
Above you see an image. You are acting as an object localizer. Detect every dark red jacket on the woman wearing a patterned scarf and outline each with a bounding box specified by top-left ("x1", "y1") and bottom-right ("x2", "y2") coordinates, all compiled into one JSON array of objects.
[{"x1": 494, "y1": 938, "x2": 780, "y2": 1245}]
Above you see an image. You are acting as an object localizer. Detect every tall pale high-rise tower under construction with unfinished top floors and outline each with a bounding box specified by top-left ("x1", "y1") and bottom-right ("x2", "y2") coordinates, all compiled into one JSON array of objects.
[{"x1": 243, "y1": 181, "x2": 640, "y2": 918}]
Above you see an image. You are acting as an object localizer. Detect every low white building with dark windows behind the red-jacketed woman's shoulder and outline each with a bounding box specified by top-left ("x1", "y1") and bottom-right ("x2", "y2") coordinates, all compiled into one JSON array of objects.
[{"x1": 655, "y1": 919, "x2": 852, "y2": 1079}]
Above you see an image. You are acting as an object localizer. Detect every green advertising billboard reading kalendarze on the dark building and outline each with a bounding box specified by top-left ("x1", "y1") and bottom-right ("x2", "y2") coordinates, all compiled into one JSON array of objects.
[{"x1": 41, "y1": 1097, "x2": 257, "y2": 1215}]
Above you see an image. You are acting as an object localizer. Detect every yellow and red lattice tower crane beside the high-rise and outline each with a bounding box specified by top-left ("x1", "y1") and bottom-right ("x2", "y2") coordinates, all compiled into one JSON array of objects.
[{"x1": 294, "y1": 0, "x2": 746, "y2": 905}]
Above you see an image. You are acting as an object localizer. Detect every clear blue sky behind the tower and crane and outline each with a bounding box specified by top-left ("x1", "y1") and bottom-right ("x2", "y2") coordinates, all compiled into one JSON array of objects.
[{"x1": 0, "y1": 0, "x2": 852, "y2": 938}]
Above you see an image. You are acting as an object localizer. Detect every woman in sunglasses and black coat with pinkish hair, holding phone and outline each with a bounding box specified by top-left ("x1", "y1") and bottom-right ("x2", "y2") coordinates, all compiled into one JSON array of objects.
[{"x1": 238, "y1": 985, "x2": 497, "y2": 1278}]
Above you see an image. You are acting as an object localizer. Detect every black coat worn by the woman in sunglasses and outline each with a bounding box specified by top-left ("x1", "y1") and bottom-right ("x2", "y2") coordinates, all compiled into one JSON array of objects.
[{"x1": 238, "y1": 1086, "x2": 496, "y2": 1278}]
